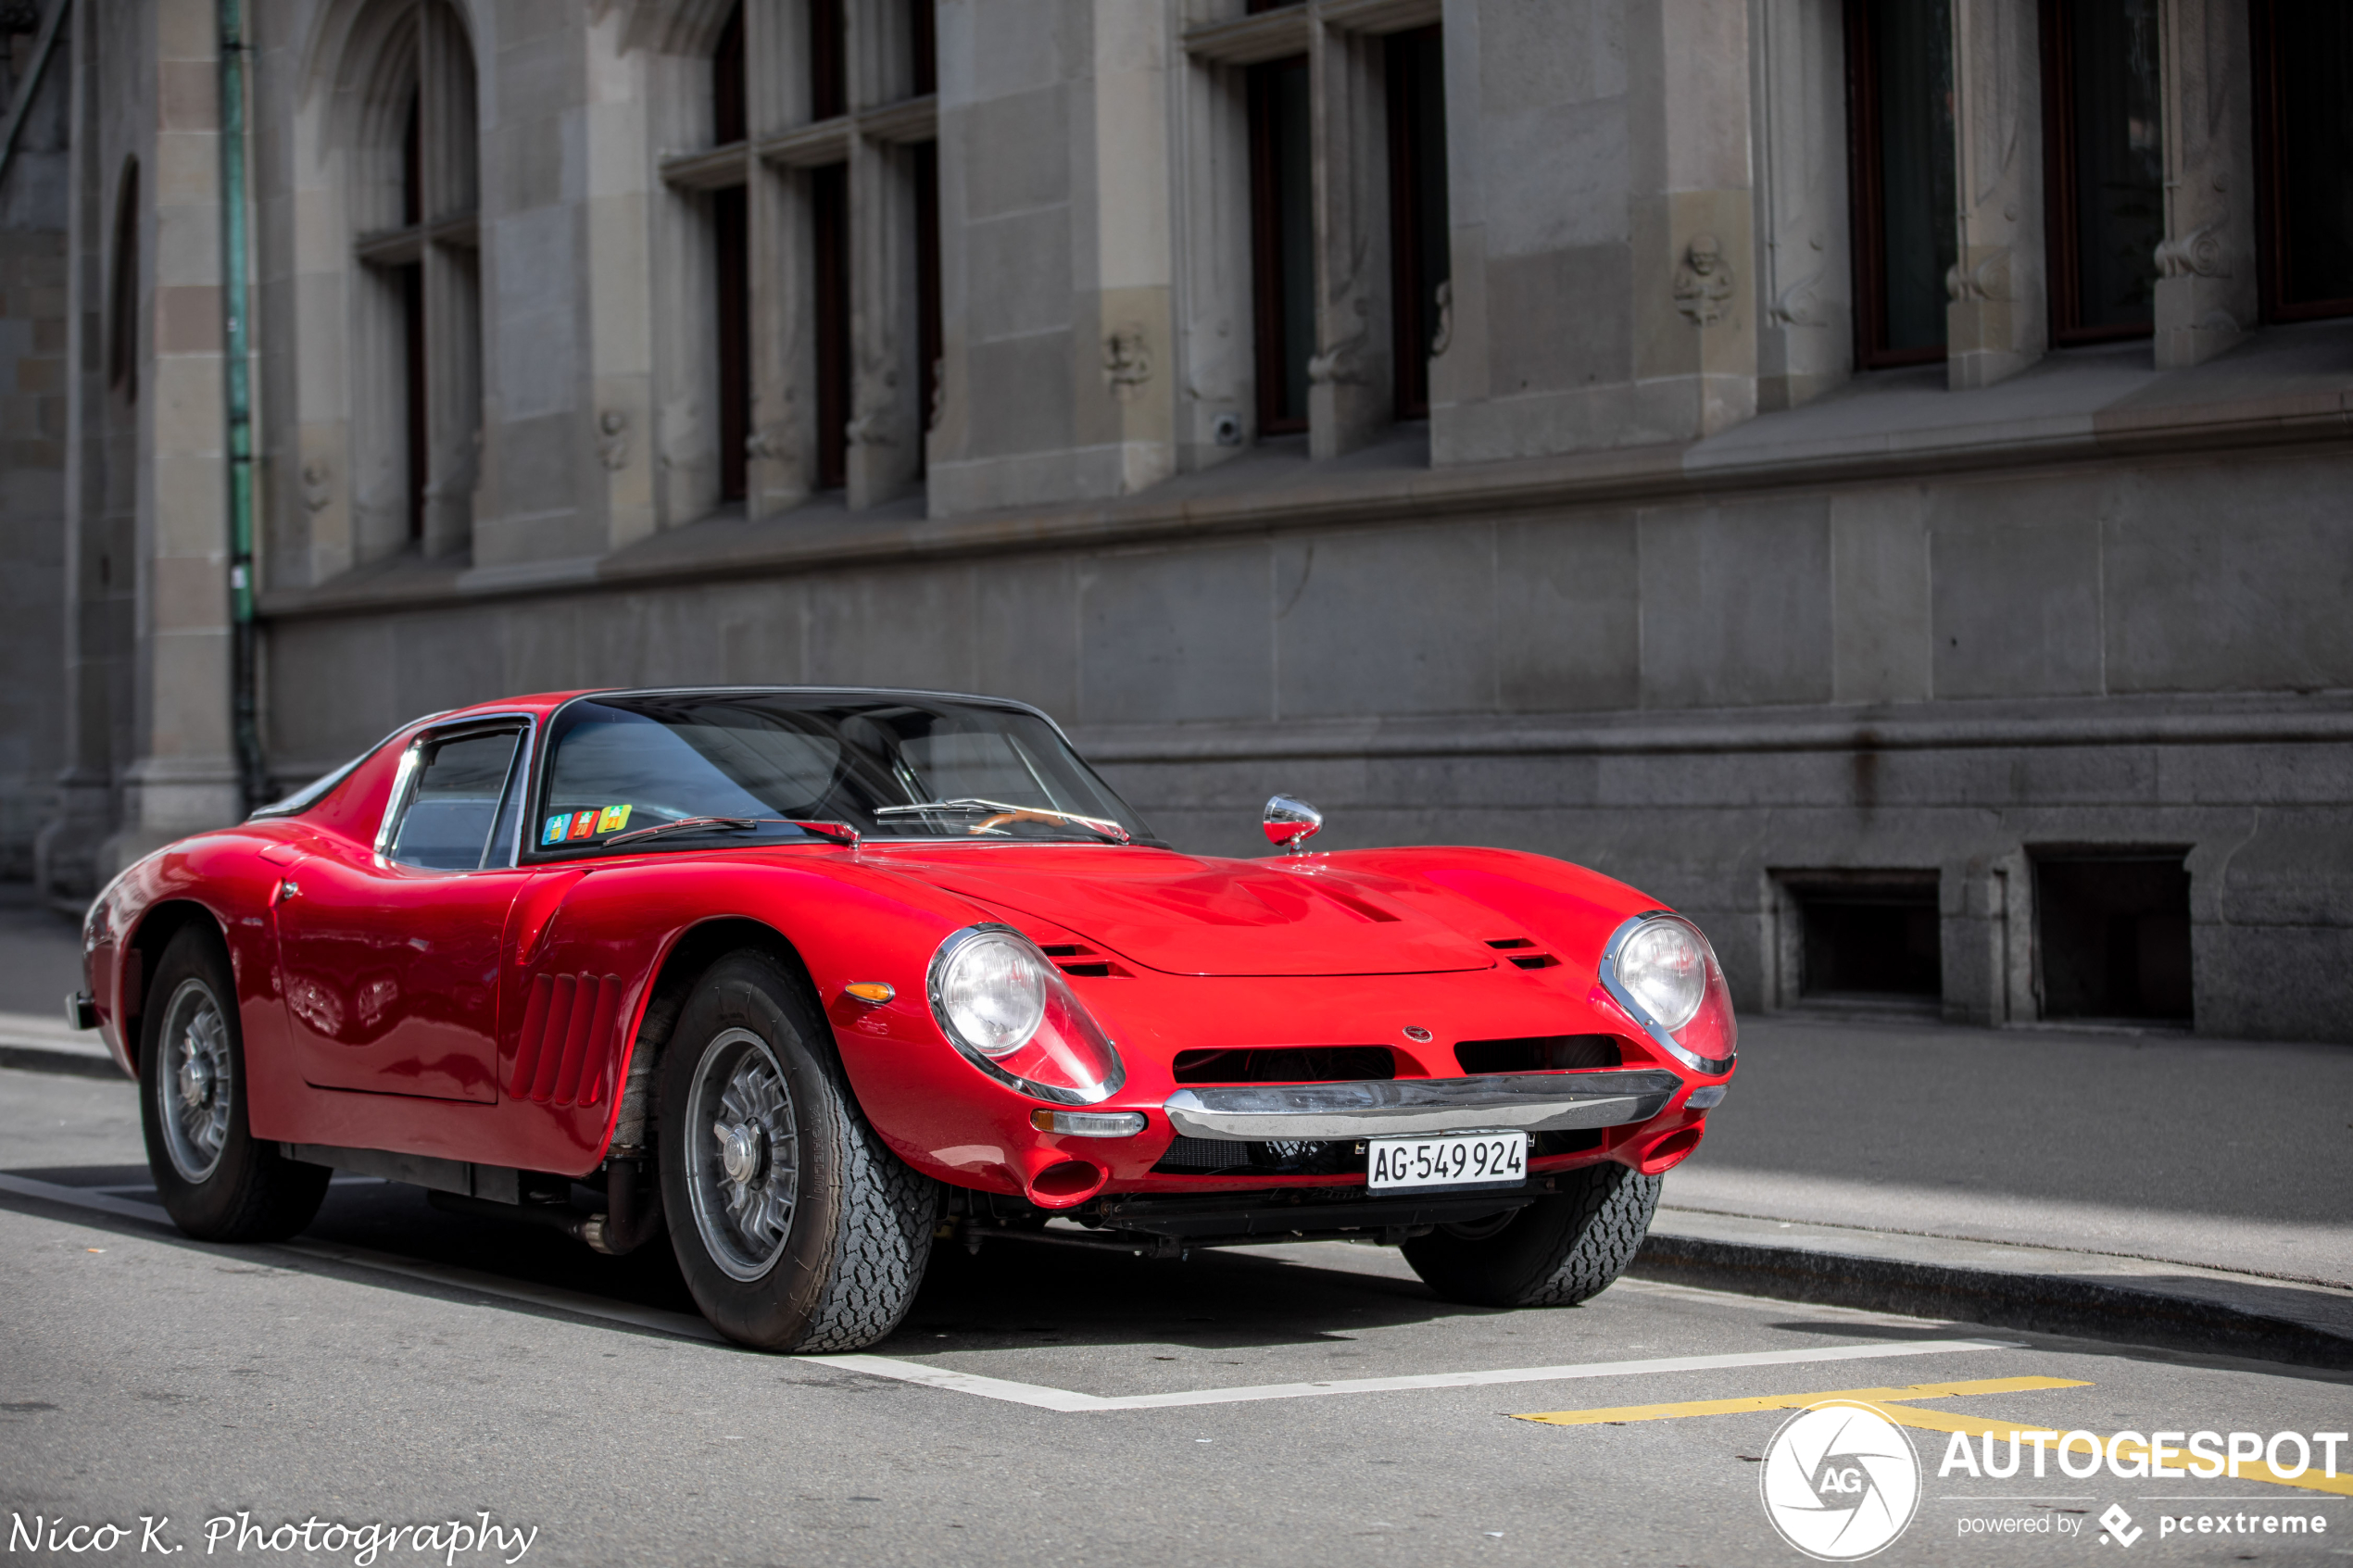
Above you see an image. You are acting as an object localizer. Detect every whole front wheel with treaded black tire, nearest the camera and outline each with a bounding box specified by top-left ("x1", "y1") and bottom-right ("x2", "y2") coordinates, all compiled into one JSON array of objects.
[{"x1": 657, "y1": 952, "x2": 938, "y2": 1351}]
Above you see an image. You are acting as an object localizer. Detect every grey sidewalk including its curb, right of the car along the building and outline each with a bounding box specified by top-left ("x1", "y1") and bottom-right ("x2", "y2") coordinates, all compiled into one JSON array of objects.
[{"x1": 1638, "y1": 1013, "x2": 2353, "y2": 1366}]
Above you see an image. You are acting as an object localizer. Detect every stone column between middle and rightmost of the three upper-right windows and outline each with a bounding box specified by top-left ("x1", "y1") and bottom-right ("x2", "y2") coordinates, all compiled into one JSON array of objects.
[{"x1": 2158, "y1": 0, "x2": 2257, "y2": 370}]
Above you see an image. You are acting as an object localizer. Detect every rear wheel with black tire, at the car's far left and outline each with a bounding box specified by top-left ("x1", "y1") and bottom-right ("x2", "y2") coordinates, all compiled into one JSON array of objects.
[{"x1": 139, "y1": 926, "x2": 334, "y2": 1241}]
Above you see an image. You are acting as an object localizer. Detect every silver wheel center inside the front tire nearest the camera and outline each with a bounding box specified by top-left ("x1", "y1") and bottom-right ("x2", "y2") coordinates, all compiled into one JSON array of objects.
[{"x1": 687, "y1": 1030, "x2": 800, "y2": 1279}]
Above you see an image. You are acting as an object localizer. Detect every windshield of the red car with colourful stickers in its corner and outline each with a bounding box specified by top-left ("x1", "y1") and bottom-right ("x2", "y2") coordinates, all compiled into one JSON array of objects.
[{"x1": 532, "y1": 691, "x2": 1151, "y2": 853}]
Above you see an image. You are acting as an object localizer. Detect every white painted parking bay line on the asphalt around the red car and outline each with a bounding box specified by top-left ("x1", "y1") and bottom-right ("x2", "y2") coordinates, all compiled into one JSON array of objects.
[{"x1": 0, "y1": 1175, "x2": 2023, "y2": 1415}]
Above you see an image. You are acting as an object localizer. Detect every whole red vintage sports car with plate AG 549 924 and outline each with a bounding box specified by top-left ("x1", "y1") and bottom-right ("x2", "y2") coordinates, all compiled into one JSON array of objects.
[{"x1": 70, "y1": 689, "x2": 1734, "y2": 1349}]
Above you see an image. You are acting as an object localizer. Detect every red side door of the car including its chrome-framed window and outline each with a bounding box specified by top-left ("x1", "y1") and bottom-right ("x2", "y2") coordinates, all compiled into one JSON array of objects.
[{"x1": 271, "y1": 717, "x2": 532, "y2": 1100}]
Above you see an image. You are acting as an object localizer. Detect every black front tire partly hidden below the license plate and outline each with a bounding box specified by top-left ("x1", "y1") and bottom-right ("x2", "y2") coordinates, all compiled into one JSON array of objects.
[{"x1": 1403, "y1": 1163, "x2": 1666, "y2": 1307}]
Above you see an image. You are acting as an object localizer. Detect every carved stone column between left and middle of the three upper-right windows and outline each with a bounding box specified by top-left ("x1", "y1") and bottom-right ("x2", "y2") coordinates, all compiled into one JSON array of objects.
[{"x1": 1944, "y1": 0, "x2": 2049, "y2": 390}]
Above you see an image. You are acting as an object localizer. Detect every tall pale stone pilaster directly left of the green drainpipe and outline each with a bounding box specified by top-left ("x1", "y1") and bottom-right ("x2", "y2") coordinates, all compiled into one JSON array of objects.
[{"x1": 114, "y1": 0, "x2": 245, "y2": 874}]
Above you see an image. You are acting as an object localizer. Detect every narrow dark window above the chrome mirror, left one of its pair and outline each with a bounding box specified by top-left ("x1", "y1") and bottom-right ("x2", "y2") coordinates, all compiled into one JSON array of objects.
[{"x1": 1250, "y1": 54, "x2": 1315, "y2": 435}]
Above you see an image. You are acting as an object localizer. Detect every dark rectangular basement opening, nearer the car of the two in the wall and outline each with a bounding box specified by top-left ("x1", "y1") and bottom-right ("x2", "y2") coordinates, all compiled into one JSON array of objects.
[{"x1": 1781, "y1": 870, "x2": 1944, "y2": 1006}]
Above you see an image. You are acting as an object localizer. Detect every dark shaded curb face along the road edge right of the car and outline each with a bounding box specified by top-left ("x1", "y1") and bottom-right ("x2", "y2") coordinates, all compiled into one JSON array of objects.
[{"x1": 1626, "y1": 1235, "x2": 2353, "y2": 1371}]
